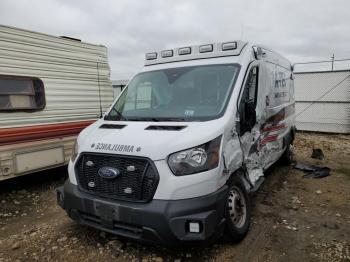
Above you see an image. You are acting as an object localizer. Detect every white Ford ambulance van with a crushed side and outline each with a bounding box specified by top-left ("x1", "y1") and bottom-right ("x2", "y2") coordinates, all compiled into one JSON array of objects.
[{"x1": 57, "y1": 41, "x2": 295, "y2": 244}]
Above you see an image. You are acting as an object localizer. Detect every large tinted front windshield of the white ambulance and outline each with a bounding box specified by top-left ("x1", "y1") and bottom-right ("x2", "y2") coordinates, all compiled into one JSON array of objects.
[{"x1": 105, "y1": 64, "x2": 240, "y2": 121}]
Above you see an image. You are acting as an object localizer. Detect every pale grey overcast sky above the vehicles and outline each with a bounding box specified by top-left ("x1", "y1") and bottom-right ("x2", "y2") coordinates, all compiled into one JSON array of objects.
[{"x1": 0, "y1": 0, "x2": 350, "y2": 79}]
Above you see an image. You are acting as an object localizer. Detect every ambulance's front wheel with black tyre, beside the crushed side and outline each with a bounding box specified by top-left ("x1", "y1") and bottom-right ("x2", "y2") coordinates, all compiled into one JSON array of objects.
[{"x1": 225, "y1": 174, "x2": 251, "y2": 243}]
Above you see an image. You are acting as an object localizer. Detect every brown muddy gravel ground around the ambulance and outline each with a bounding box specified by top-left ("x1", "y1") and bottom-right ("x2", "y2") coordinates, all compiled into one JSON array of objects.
[{"x1": 0, "y1": 133, "x2": 350, "y2": 262}]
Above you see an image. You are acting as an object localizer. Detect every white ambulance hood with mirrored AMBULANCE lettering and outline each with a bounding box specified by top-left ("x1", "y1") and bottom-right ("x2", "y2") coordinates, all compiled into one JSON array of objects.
[{"x1": 78, "y1": 119, "x2": 224, "y2": 161}]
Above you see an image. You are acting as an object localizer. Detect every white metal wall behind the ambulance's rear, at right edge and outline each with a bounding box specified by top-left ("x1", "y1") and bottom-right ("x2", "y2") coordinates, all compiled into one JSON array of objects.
[{"x1": 294, "y1": 70, "x2": 350, "y2": 134}]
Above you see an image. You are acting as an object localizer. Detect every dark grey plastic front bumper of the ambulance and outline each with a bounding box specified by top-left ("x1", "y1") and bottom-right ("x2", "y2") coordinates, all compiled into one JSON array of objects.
[{"x1": 57, "y1": 180, "x2": 228, "y2": 245}]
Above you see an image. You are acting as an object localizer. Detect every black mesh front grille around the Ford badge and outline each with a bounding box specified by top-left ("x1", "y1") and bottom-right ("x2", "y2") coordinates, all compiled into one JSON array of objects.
[{"x1": 75, "y1": 153, "x2": 159, "y2": 202}]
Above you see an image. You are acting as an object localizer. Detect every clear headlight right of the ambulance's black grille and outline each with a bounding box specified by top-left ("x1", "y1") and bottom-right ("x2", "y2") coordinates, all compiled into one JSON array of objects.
[{"x1": 168, "y1": 136, "x2": 221, "y2": 176}]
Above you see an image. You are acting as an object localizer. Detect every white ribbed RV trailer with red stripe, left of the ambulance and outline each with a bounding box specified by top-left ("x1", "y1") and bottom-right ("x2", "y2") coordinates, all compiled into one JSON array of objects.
[{"x1": 0, "y1": 25, "x2": 113, "y2": 180}]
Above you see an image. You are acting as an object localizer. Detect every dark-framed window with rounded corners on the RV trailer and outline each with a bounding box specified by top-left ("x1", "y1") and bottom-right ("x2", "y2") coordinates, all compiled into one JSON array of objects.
[{"x1": 0, "y1": 75, "x2": 45, "y2": 111}]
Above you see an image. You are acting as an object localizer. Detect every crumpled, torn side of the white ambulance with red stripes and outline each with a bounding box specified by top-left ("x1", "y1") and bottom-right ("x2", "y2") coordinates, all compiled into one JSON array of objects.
[{"x1": 235, "y1": 54, "x2": 295, "y2": 186}]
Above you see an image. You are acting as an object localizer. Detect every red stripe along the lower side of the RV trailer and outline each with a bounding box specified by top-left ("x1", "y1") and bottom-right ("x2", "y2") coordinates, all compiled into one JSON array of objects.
[{"x1": 0, "y1": 120, "x2": 95, "y2": 145}]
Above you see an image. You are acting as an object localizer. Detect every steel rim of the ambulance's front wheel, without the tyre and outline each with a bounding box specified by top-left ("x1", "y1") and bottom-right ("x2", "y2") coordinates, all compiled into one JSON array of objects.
[{"x1": 227, "y1": 187, "x2": 247, "y2": 228}]
